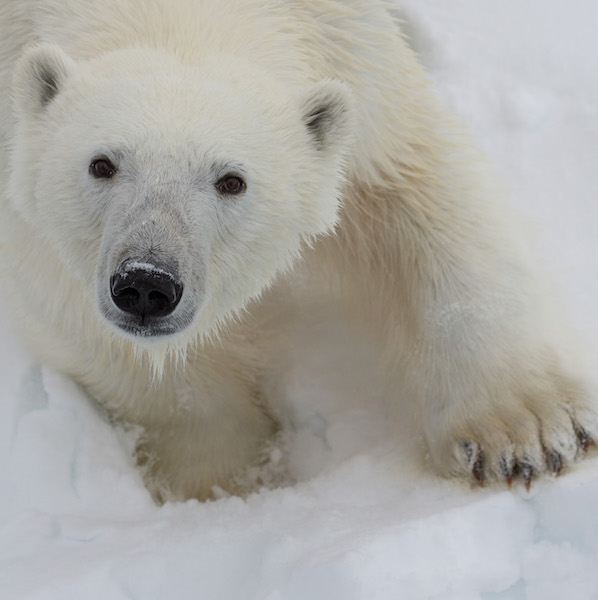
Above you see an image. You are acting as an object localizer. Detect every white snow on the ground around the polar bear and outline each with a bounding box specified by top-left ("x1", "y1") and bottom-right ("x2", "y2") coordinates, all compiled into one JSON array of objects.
[{"x1": 0, "y1": 0, "x2": 598, "y2": 600}]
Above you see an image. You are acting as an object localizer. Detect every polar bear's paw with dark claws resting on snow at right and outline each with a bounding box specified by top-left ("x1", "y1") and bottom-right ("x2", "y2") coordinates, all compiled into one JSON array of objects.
[{"x1": 429, "y1": 377, "x2": 598, "y2": 490}]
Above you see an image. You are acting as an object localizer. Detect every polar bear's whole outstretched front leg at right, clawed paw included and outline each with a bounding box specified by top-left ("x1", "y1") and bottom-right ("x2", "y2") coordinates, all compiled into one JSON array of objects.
[{"x1": 331, "y1": 168, "x2": 598, "y2": 486}]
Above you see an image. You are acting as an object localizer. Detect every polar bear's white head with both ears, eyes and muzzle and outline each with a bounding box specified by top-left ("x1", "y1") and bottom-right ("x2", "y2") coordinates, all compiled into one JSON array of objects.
[{"x1": 11, "y1": 46, "x2": 352, "y2": 343}]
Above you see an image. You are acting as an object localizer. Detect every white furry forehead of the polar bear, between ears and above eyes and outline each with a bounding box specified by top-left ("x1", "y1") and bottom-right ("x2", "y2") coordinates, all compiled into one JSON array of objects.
[{"x1": 56, "y1": 57, "x2": 301, "y2": 148}]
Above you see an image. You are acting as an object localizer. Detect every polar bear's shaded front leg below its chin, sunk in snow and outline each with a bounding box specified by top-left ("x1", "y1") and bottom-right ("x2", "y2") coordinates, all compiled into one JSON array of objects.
[{"x1": 106, "y1": 342, "x2": 278, "y2": 503}]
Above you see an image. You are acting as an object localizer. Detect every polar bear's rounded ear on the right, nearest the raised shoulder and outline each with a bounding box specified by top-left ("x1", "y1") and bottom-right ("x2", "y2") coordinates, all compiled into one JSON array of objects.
[{"x1": 302, "y1": 80, "x2": 353, "y2": 152}]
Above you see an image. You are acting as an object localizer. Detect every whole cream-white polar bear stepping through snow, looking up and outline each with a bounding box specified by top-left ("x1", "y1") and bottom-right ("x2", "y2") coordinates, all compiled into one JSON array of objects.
[{"x1": 0, "y1": 0, "x2": 598, "y2": 500}]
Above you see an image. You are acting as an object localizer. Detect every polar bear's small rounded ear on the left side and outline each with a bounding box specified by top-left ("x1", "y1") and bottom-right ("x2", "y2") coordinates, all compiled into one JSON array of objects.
[{"x1": 13, "y1": 44, "x2": 75, "y2": 114}]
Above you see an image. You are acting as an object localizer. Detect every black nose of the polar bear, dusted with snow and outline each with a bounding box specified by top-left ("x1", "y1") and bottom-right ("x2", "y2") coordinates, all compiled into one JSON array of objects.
[{"x1": 110, "y1": 262, "x2": 183, "y2": 325}]
